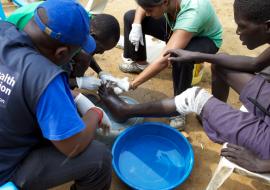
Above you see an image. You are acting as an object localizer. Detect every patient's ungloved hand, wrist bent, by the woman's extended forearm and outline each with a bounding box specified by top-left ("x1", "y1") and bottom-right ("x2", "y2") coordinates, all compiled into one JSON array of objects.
[{"x1": 163, "y1": 49, "x2": 198, "y2": 63}]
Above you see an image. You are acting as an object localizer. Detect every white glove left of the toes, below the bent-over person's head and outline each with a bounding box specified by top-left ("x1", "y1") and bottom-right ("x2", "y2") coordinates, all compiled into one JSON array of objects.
[{"x1": 76, "y1": 76, "x2": 101, "y2": 90}]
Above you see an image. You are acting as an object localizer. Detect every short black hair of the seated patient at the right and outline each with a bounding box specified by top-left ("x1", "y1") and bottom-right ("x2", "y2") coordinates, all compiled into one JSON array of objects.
[{"x1": 234, "y1": 0, "x2": 270, "y2": 23}]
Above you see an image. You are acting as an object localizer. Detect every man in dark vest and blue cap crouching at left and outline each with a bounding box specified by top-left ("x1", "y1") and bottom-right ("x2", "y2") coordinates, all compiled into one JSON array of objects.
[{"x1": 0, "y1": 0, "x2": 111, "y2": 190}]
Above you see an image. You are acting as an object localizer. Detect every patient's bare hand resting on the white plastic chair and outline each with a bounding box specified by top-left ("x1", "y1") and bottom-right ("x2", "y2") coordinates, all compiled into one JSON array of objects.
[{"x1": 221, "y1": 144, "x2": 269, "y2": 173}]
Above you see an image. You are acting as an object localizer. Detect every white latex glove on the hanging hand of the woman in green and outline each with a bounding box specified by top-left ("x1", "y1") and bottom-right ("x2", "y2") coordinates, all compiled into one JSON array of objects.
[{"x1": 129, "y1": 23, "x2": 144, "y2": 51}]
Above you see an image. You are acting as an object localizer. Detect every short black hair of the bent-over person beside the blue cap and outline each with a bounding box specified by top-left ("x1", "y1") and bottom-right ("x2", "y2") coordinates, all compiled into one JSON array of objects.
[{"x1": 91, "y1": 14, "x2": 120, "y2": 45}]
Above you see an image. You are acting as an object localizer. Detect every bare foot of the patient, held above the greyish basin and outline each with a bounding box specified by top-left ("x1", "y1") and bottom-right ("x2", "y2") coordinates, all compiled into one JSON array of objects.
[{"x1": 98, "y1": 84, "x2": 129, "y2": 123}]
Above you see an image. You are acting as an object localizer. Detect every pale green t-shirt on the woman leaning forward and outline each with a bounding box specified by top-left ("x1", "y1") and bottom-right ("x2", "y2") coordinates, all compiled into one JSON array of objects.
[{"x1": 165, "y1": 0, "x2": 222, "y2": 47}]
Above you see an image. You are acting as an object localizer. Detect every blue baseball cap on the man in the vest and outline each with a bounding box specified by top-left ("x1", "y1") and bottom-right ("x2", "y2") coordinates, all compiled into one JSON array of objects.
[{"x1": 34, "y1": 0, "x2": 96, "y2": 53}]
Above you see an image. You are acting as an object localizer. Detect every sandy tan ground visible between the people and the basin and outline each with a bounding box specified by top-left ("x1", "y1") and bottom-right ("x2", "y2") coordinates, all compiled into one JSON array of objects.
[{"x1": 3, "y1": 0, "x2": 270, "y2": 190}]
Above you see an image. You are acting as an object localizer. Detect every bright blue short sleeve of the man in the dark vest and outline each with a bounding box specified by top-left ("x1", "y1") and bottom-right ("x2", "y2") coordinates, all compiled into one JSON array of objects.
[{"x1": 36, "y1": 74, "x2": 85, "y2": 141}]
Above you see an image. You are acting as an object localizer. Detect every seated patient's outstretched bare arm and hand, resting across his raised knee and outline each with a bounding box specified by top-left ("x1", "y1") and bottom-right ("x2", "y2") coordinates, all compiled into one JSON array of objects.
[{"x1": 164, "y1": 48, "x2": 270, "y2": 73}]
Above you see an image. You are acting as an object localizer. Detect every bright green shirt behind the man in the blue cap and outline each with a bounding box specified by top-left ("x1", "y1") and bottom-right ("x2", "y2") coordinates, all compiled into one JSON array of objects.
[{"x1": 6, "y1": 1, "x2": 42, "y2": 30}]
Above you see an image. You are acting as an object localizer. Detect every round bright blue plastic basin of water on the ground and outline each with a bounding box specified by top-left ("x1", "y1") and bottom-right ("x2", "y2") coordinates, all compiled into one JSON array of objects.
[{"x1": 112, "y1": 122, "x2": 194, "y2": 190}]
